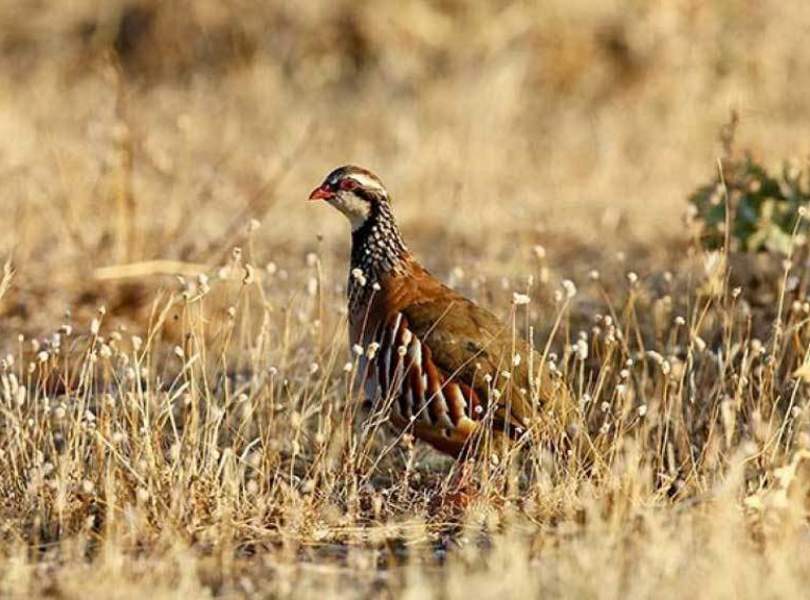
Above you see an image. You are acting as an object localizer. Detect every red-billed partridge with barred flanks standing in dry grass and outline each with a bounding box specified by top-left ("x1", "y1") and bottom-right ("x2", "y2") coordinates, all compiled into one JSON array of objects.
[{"x1": 309, "y1": 165, "x2": 568, "y2": 458}]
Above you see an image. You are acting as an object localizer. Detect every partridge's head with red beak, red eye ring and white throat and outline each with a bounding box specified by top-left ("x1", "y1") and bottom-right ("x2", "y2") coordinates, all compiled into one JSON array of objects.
[{"x1": 309, "y1": 165, "x2": 389, "y2": 230}]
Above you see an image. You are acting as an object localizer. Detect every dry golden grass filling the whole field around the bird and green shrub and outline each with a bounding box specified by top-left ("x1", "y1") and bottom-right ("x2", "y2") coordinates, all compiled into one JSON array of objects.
[{"x1": 0, "y1": 0, "x2": 810, "y2": 598}]
